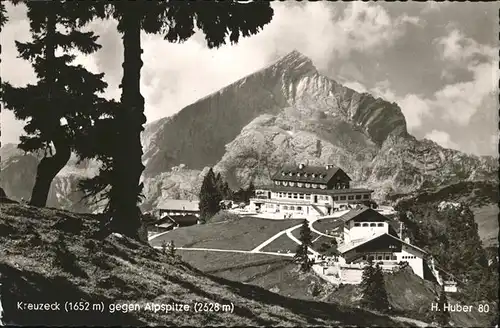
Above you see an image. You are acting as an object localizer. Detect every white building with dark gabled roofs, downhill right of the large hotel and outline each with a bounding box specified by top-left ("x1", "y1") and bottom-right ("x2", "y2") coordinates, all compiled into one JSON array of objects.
[{"x1": 334, "y1": 207, "x2": 427, "y2": 279}]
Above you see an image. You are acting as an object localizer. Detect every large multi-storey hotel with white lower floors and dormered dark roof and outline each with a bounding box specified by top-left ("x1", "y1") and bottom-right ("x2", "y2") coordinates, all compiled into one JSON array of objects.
[{"x1": 250, "y1": 164, "x2": 373, "y2": 216}]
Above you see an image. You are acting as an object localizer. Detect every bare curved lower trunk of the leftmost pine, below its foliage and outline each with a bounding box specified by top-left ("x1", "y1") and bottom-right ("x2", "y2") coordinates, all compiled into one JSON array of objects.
[{"x1": 30, "y1": 127, "x2": 71, "y2": 207}]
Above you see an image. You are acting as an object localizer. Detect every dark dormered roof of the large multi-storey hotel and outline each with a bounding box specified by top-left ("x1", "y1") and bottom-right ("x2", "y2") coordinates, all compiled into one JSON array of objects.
[{"x1": 272, "y1": 164, "x2": 351, "y2": 184}]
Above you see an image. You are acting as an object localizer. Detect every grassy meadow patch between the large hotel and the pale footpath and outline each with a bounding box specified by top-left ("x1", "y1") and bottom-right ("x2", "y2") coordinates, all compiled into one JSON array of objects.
[{"x1": 152, "y1": 217, "x2": 302, "y2": 251}]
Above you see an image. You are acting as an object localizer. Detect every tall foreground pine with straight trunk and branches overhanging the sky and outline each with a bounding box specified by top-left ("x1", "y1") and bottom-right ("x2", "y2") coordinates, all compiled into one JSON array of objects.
[{"x1": 90, "y1": 1, "x2": 273, "y2": 238}]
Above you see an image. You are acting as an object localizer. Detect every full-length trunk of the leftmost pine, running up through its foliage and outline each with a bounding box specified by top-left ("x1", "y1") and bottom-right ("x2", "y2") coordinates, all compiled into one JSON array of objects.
[{"x1": 30, "y1": 4, "x2": 71, "y2": 207}]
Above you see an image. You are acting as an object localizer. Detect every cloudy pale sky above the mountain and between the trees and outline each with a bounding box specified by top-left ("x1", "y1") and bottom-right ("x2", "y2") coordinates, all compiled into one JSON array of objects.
[{"x1": 0, "y1": 2, "x2": 500, "y2": 155}]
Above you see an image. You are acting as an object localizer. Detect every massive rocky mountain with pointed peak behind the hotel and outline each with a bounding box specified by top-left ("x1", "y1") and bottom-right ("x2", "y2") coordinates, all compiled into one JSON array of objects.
[{"x1": 1, "y1": 51, "x2": 498, "y2": 213}]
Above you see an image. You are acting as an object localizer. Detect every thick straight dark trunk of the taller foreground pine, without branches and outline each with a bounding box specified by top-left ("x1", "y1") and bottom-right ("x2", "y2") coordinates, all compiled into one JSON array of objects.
[{"x1": 111, "y1": 6, "x2": 146, "y2": 239}]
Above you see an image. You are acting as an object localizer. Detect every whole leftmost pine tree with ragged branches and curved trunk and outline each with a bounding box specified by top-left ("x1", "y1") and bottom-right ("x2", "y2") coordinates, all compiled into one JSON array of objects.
[{"x1": 2, "y1": 1, "x2": 113, "y2": 206}]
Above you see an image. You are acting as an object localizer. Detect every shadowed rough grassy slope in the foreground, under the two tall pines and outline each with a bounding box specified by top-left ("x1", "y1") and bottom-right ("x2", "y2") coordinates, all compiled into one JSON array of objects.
[{"x1": 0, "y1": 204, "x2": 400, "y2": 327}]
